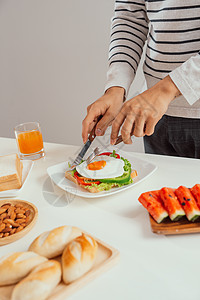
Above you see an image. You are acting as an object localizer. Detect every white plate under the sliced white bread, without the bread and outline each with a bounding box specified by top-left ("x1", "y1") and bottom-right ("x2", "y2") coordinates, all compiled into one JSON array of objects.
[{"x1": 0, "y1": 160, "x2": 33, "y2": 198}]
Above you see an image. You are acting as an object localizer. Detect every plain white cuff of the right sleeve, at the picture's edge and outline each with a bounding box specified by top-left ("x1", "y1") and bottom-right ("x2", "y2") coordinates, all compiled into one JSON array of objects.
[{"x1": 169, "y1": 52, "x2": 200, "y2": 105}]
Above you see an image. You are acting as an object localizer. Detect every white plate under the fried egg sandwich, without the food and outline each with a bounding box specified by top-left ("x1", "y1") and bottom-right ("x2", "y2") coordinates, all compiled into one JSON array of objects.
[{"x1": 47, "y1": 151, "x2": 157, "y2": 198}]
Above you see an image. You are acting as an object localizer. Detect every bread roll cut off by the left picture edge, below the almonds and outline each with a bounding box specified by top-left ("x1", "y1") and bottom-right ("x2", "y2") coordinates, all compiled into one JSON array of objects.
[{"x1": 0, "y1": 251, "x2": 47, "y2": 286}]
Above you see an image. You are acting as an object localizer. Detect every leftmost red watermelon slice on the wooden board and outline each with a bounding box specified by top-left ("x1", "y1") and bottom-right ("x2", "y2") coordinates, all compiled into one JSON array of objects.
[{"x1": 138, "y1": 191, "x2": 168, "y2": 223}]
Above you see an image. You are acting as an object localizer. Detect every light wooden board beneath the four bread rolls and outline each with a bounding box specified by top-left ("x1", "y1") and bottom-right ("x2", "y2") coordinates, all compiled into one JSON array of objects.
[{"x1": 0, "y1": 237, "x2": 119, "y2": 300}]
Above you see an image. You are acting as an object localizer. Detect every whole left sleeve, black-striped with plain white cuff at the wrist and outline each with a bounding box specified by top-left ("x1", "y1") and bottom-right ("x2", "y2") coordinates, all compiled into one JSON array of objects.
[{"x1": 105, "y1": 0, "x2": 148, "y2": 94}]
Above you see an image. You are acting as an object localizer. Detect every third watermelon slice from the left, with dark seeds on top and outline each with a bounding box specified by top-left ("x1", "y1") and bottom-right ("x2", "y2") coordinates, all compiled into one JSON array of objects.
[{"x1": 175, "y1": 186, "x2": 200, "y2": 221}]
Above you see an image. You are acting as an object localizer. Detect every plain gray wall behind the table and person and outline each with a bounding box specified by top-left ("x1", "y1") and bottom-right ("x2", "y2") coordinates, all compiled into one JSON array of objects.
[{"x1": 0, "y1": 0, "x2": 144, "y2": 151}]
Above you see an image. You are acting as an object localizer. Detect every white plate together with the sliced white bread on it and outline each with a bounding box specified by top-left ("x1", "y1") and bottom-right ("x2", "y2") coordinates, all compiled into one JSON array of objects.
[{"x1": 0, "y1": 154, "x2": 33, "y2": 198}]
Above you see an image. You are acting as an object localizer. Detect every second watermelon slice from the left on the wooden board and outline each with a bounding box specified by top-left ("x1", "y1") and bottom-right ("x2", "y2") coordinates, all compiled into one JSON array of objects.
[{"x1": 160, "y1": 187, "x2": 185, "y2": 221}]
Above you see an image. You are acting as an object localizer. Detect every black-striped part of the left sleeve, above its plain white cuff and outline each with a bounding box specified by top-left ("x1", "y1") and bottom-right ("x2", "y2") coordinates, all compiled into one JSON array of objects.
[{"x1": 109, "y1": 0, "x2": 149, "y2": 73}]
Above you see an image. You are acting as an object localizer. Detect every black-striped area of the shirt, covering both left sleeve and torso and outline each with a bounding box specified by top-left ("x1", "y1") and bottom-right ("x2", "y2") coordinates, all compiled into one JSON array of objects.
[{"x1": 109, "y1": 0, "x2": 200, "y2": 79}]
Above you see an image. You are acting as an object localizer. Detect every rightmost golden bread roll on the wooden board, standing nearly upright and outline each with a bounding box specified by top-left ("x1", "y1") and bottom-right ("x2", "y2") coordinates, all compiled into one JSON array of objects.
[{"x1": 62, "y1": 234, "x2": 98, "y2": 284}]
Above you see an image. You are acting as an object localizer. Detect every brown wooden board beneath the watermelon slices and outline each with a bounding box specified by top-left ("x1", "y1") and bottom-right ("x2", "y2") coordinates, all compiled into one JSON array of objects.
[{"x1": 149, "y1": 215, "x2": 200, "y2": 235}]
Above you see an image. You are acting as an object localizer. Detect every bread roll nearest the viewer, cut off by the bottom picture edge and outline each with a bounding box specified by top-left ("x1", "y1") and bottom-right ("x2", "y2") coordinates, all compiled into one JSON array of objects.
[{"x1": 11, "y1": 260, "x2": 61, "y2": 300}]
